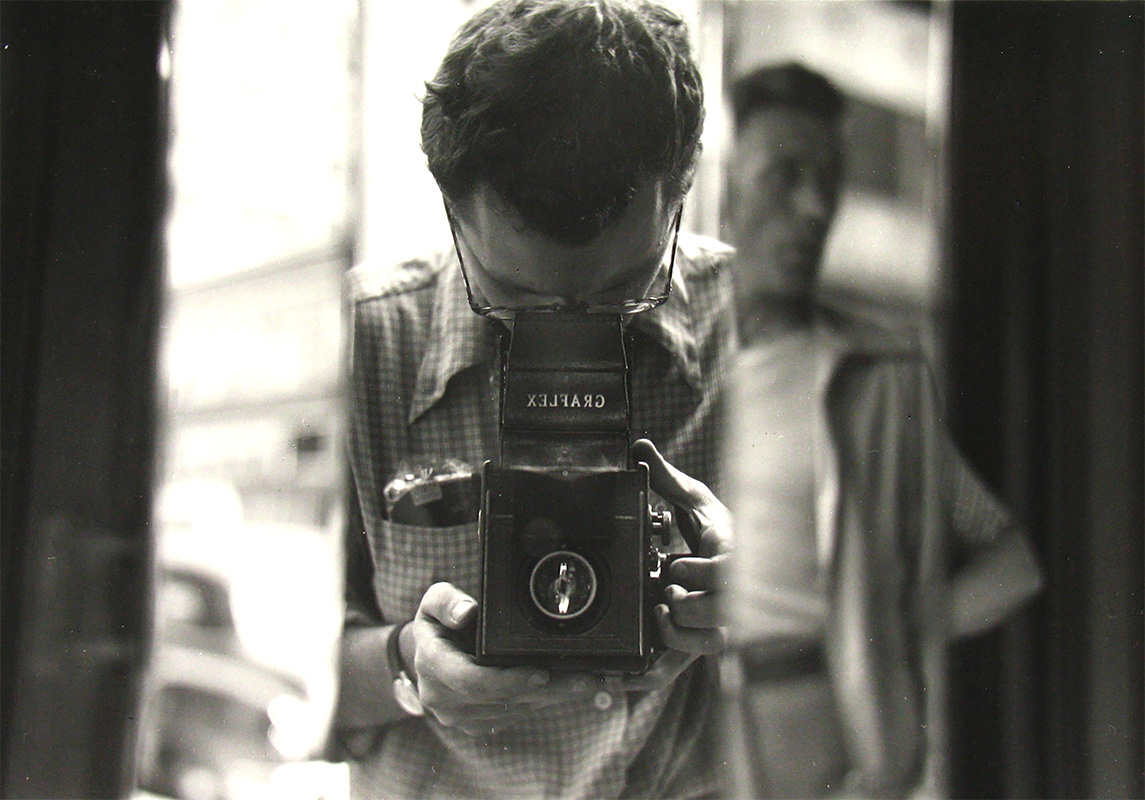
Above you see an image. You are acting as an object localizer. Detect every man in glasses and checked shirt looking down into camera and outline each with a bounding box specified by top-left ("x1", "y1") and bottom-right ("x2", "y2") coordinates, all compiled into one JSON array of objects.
[{"x1": 337, "y1": 0, "x2": 734, "y2": 798}]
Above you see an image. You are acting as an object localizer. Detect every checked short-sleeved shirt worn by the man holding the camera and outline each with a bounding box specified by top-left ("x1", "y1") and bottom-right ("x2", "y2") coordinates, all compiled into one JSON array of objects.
[{"x1": 347, "y1": 235, "x2": 734, "y2": 798}]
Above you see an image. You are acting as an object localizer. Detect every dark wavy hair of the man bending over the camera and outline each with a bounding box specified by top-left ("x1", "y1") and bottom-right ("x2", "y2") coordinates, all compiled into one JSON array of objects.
[{"x1": 421, "y1": 0, "x2": 703, "y2": 245}]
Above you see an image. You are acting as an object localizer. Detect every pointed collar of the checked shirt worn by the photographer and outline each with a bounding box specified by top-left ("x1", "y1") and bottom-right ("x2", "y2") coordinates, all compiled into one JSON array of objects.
[{"x1": 409, "y1": 249, "x2": 701, "y2": 423}]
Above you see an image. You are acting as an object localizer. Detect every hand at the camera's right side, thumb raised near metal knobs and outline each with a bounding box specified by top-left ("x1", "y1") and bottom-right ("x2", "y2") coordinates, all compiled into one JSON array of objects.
[{"x1": 624, "y1": 439, "x2": 732, "y2": 689}]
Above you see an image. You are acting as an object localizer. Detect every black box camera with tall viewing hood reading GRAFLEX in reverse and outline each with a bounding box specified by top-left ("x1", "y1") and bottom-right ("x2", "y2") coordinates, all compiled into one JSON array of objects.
[{"x1": 475, "y1": 311, "x2": 671, "y2": 673}]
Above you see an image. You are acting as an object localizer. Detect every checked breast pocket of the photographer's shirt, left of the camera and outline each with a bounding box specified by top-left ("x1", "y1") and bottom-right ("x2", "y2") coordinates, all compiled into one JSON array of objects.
[{"x1": 373, "y1": 520, "x2": 481, "y2": 623}]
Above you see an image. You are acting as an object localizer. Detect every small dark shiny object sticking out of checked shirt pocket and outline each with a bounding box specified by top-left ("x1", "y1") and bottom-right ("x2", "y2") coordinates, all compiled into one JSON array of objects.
[{"x1": 382, "y1": 458, "x2": 481, "y2": 528}]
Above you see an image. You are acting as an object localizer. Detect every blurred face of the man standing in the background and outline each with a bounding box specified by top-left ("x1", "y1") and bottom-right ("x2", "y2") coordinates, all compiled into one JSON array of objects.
[{"x1": 728, "y1": 108, "x2": 842, "y2": 302}]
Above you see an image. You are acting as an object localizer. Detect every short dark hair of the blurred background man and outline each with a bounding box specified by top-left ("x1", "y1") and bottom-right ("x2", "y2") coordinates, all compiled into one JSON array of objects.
[{"x1": 728, "y1": 61, "x2": 845, "y2": 130}]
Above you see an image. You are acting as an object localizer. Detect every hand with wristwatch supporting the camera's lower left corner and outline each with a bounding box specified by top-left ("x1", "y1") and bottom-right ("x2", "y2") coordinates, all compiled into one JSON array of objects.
[{"x1": 402, "y1": 583, "x2": 599, "y2": 735}]
